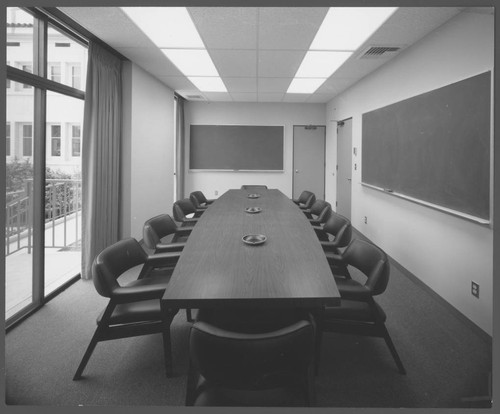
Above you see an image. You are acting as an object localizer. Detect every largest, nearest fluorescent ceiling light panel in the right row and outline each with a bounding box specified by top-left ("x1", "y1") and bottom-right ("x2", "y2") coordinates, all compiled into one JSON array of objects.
[{"x1": 309, "y1": 7, "x2": 397, "y2": 51}]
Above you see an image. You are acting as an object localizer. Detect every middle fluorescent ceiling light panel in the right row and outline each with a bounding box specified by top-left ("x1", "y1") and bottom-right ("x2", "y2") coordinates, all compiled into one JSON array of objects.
[{"x1": 295, "y1": 51, "x2": 352, "y2": 78}]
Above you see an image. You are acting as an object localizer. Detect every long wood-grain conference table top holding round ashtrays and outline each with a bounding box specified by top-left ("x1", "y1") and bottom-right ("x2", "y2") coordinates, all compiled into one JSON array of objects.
[{"x1": 162, "y1": 189, "x2": 340, "y2": 308}]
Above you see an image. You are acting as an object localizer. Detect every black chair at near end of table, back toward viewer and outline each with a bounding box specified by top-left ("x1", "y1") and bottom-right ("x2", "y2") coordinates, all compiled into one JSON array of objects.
[{"x1": 186, "y1": 309, "x2": 315, "y2": 407}]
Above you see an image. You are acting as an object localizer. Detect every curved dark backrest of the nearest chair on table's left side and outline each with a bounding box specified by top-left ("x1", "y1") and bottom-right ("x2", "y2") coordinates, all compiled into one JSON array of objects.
[{"x1": 92, "y1": 237, "x2": 148, "y2": 298}]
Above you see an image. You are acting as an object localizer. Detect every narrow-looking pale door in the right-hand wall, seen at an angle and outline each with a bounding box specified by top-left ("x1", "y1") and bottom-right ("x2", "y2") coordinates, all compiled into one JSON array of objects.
[{"x1": 336, "y1": 118, "x2": 352, "y2": 220}]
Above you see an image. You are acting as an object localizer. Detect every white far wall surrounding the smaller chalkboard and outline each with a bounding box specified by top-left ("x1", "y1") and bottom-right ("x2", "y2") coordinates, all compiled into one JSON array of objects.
[{"x1": 185, "y1": 102, "x2": 326, "y2": 198}]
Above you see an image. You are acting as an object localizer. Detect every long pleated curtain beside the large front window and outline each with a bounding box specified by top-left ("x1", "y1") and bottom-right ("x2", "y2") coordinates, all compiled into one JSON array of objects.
[{"x1": 82, "y1": 42, "x2": 122, "y2": 279}]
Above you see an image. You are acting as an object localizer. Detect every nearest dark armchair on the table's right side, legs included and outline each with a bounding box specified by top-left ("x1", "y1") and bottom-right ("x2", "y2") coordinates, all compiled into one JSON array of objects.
[{"x1": 316, "y1": 239, "x2": 406, "y2": 374}]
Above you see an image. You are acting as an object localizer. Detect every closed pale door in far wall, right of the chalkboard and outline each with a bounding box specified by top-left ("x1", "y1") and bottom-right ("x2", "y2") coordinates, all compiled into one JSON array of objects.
[{"x1": 293, "y1": 125, "x2": 326, "y2": 200}]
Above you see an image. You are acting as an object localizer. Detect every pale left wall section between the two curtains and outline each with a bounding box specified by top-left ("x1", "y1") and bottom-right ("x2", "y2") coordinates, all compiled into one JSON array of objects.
[{"x1": 122, "y1": 62, "x2": 175, "y2": 240}]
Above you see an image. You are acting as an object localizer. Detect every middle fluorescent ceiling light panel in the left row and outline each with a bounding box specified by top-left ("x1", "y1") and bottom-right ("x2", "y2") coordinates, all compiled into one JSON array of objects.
[{"x1": 162, "y1": 49, "x2": 219, "y2": 76}]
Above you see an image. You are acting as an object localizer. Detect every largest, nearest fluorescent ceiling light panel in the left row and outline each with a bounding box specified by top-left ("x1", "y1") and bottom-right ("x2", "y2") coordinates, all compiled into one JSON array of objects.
[{"x1": 121, "y1": 7, "x2": 205, "y2": 49}]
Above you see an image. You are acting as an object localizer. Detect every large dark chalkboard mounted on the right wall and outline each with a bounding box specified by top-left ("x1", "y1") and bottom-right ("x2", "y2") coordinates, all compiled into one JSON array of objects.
[{"x1": 362, "y1": 72, "x2": 491, "y2": 220}]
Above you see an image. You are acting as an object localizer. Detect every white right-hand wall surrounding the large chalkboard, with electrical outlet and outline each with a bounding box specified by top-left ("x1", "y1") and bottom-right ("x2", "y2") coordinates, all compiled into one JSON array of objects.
[{"x1": 326, "y1": 13, "x2": 494, "y2": 335}]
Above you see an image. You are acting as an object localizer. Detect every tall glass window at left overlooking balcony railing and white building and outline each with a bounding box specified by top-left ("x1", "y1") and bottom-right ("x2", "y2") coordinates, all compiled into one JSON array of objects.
[{"x1": 5, "y1": 7, "x2": 87, "y2": 325}]
